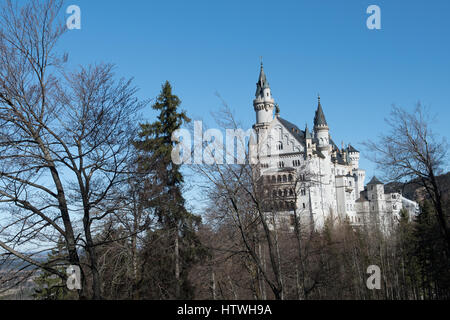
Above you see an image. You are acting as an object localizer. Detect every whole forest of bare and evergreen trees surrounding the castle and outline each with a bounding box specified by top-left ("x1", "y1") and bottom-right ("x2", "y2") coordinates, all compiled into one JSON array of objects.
[{"x1": 0, "y1": 0, "x2": 450, "y2": 300}]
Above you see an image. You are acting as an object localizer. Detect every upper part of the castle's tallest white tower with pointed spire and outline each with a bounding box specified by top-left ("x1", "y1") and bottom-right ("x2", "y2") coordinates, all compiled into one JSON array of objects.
[{"x1": 253, "y1": 62, "x2": 275, "y2": 129}]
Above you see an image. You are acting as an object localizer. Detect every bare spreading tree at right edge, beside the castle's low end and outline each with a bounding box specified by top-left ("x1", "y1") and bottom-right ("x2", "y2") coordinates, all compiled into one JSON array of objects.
[{"x1": 366, "y1": 103, "x2": 450, "y2": 254}]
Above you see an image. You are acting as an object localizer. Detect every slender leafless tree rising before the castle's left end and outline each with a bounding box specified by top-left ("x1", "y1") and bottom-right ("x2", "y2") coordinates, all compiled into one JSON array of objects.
[{"x1": 192, "y1": 105, "x2": 283, "y2": 299}]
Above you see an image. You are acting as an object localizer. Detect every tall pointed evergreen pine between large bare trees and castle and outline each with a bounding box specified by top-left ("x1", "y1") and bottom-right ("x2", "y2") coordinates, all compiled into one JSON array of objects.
[{"x1": 135, "y1": 81, "x2": 203, "y2": 299}]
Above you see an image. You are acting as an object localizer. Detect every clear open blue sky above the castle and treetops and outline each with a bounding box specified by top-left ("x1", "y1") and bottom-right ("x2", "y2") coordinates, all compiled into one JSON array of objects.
[{"x1": 60, "y1": 0, "x2": 450, "y2": 209}]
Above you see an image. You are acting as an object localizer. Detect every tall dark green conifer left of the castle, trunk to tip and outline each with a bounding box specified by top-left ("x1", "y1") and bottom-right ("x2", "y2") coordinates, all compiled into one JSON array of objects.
[{"x1": 135, "y1": 82, "x2": 204, "y2": 299}]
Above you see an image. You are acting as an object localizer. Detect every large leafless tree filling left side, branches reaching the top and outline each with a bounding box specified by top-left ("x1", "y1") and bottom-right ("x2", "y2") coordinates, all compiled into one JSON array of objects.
[{"x1": 0, "y1": 0, "x2": 142, "y2": 299}]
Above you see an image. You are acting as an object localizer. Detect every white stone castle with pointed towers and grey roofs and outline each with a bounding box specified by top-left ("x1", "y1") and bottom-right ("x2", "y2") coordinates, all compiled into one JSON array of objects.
[{"x1": 250, "y1": 65, "x2": 418, "y2": 228}]
